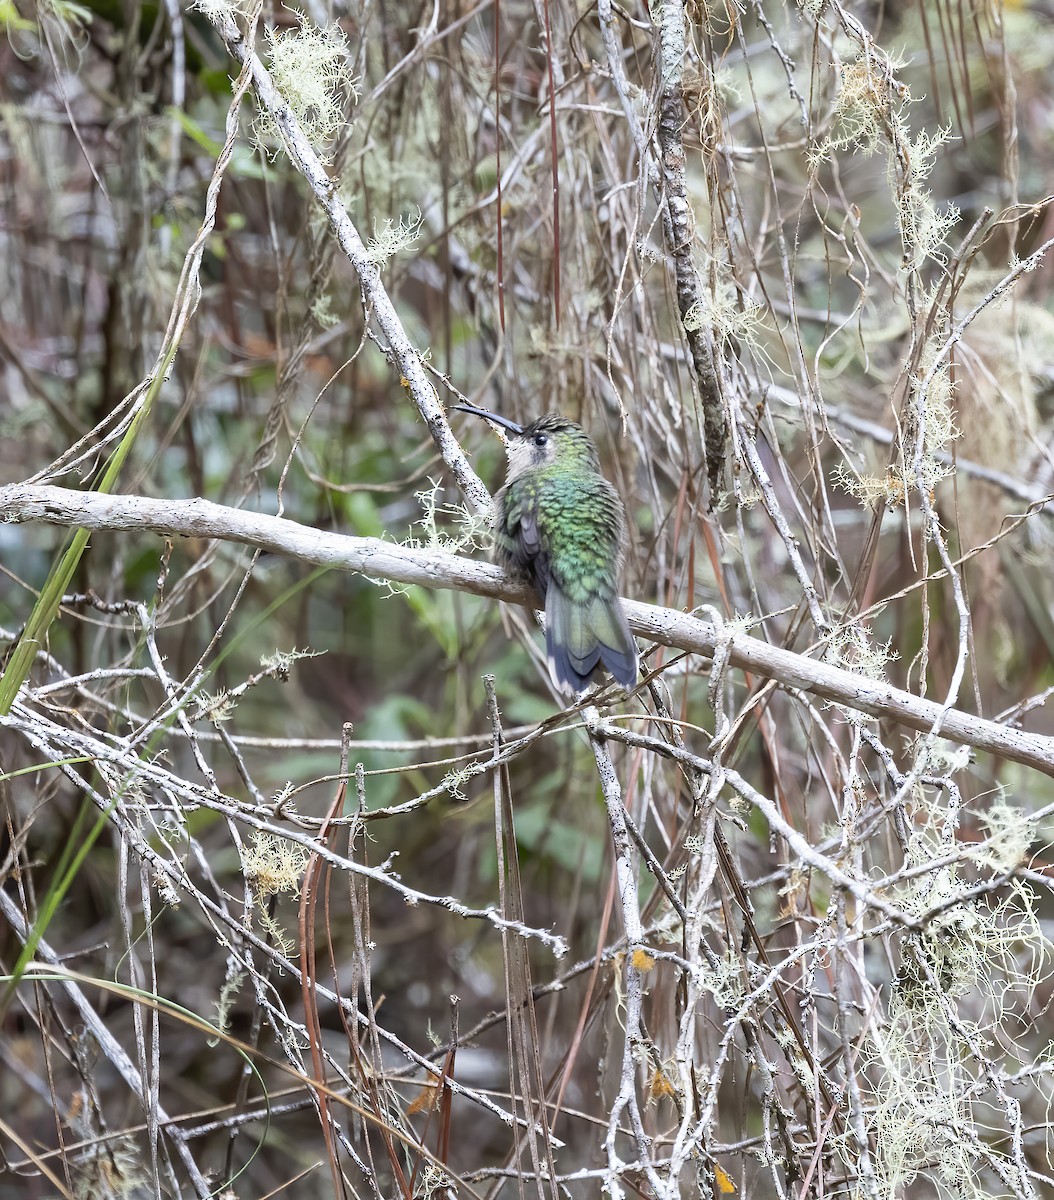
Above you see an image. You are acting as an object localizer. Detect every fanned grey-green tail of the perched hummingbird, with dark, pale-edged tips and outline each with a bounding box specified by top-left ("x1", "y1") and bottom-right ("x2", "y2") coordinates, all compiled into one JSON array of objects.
[{"x1": 545, "y1": 577, "x2": 637, "y2": 692}]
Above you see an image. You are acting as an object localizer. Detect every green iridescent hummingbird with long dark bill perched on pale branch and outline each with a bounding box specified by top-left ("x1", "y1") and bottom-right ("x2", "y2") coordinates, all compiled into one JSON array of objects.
[{"x1": 453, "y1": 404, "x2": 637, "y2": 695}]
